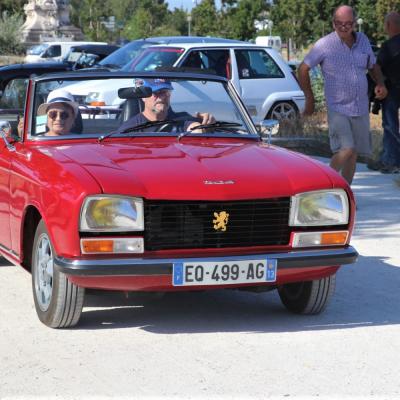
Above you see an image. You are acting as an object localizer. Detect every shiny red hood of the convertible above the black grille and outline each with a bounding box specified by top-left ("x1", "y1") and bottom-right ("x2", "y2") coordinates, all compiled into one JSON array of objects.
[{"x1": 58, "y1": 138, "x2": 344, "y2": 200}]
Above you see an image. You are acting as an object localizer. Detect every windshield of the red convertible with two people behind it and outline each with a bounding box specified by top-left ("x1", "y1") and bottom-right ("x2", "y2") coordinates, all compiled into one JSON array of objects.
[{"x1": 29, "y1": 75, "x2": 255, "y2": 139}]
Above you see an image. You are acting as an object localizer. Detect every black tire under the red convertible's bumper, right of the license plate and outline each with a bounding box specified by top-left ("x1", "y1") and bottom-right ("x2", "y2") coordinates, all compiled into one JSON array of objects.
[{"x1": 278, "y1": 274, "x2": 336, "y2": 315}]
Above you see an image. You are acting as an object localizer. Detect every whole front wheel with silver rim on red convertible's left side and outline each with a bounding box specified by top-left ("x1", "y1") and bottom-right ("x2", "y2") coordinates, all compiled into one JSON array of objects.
[{"x1": 31, "y1": 220, "x2": 85, "y2": 328}]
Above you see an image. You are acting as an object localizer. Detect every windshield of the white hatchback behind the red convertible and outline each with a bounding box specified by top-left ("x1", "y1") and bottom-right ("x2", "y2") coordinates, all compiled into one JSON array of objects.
[{"x1": 122, "y1": 47, "x2": 184, "y2": 72}]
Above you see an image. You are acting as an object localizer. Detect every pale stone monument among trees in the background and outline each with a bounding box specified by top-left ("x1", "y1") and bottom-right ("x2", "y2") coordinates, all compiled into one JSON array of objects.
[{"x1": 22, "y1": 0, "x2": 84, "y2": 46}]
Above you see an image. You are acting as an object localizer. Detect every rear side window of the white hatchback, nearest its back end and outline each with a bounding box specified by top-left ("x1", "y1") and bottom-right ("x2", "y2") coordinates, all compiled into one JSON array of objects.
[{"x1": 235, "y1": 49, "x2": 285, "y2": 79}]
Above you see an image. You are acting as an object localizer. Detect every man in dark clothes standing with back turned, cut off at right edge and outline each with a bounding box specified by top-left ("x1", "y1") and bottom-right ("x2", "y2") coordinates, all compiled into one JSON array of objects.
[{"x1": 378, "y1": 12, "x2": 400, "y2": 173}]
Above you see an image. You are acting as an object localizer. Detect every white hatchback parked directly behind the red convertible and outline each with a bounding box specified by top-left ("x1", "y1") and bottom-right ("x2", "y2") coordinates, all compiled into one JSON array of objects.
[{"x1": 71, "y1": 41, "x2": 305, "y2": 124}]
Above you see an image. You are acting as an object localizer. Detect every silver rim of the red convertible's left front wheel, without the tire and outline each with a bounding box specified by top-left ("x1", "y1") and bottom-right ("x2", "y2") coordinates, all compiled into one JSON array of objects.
[{"x1": 35, "y1": 234, "x2": 53, "y2": 311}]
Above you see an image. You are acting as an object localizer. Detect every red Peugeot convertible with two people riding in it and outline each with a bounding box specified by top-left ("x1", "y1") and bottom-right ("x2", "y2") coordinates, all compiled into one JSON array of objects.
[{"x1": 0, "y1": 71, "x2": 357, "y2": 328}]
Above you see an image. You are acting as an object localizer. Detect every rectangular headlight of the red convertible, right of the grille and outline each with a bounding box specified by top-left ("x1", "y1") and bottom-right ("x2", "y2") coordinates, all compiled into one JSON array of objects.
[{"x1": 289, "y1": 189, "x2": 349, "y2": 226}]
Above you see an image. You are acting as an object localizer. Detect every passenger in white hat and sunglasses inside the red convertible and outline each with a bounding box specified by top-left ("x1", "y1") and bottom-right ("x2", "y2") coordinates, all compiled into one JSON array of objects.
[{"x1": 37, "y1": 89, "x2": 79, "y2": 136}]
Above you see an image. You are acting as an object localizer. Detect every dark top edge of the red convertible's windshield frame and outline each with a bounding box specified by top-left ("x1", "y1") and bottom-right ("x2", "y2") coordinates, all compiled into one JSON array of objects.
[{"x1": 32, "y1": 68, "x2": 228, "y2": 82}]
